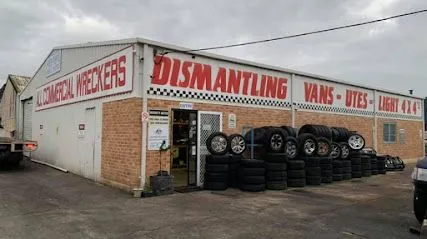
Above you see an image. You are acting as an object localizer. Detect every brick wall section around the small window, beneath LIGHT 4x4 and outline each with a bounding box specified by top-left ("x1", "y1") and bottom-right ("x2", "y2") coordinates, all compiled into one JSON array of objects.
[{"x1": 377, "y1": 118, "x2": 424, "y2": 160}]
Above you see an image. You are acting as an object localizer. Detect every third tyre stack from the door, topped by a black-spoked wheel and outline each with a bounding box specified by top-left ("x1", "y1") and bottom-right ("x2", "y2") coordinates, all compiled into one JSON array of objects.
[{"x1": 262, "y1": 126, "x2": 297, "y2": 190}]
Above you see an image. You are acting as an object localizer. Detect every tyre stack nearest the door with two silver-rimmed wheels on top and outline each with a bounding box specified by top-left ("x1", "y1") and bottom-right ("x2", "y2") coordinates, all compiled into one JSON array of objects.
[{"x1": 204, "y1": 132, "x2": 246, "y2": 190}]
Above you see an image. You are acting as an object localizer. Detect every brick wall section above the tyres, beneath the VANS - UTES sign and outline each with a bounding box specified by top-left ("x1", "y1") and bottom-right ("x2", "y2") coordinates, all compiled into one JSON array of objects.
[{"x1": 295, "y1": 111, "x2": 374, "y2": 147}]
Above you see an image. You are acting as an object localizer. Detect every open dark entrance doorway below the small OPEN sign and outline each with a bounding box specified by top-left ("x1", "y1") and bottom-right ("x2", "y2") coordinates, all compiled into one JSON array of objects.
[{"x1": 171, "y1": 110, "x2": 197, "y2": 188}]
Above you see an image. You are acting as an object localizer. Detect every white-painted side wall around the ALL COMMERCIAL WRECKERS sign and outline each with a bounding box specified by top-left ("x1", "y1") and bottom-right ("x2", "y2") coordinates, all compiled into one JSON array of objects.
[{"x1": 18, "y1": 42, "x2": 142, "y2": 180}]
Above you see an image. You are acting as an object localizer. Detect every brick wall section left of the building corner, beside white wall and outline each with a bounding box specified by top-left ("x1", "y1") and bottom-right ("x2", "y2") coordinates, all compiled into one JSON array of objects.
[{"x1": 101, "y1": 98, "x2": 142, "y2": 191}]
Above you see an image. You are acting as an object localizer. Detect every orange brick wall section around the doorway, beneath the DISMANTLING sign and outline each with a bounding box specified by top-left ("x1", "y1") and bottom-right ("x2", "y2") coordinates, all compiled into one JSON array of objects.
[{"x1": 146, "y1": 100, "x2": 291, "y2": 177}]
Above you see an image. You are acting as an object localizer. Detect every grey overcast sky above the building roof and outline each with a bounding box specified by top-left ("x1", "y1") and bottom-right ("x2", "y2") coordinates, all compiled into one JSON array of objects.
[{"x1": 0, "y1": 0, "x2": 427, "y2": 96}]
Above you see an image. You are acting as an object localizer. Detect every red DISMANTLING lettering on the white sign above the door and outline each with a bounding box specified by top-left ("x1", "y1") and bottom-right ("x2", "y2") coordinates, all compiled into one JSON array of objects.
[{"x1": 151, "y1": 56, "x2": 288, "y2": 99}]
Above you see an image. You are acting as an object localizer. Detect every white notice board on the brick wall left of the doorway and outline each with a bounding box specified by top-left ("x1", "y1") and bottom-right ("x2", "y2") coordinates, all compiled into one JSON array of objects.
[{"x1": 148, "y1": 110, "x2": 169, "y2": 150}]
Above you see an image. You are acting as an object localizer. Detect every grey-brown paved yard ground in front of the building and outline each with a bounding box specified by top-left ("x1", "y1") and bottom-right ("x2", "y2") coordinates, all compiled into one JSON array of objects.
[{"x1": 0, "y1": 162, "x2": 417, "y2": 239}]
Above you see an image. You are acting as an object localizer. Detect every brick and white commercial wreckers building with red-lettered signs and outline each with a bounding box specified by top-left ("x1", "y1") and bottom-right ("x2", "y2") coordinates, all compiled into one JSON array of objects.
[{"x1": 16, "y1": 38, "x2": 424, "y2": 191}]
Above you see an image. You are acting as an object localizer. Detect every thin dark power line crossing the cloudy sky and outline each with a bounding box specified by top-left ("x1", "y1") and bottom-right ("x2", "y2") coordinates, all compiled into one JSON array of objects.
[{"x1": 169, "y1": 9, "x2": 427, "y2": 55}]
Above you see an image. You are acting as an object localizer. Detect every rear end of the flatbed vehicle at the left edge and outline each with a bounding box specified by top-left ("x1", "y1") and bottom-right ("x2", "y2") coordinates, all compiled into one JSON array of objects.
[{"x1": 0, "y1": 137, "x2": 37, "y2": 166}]
